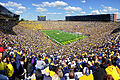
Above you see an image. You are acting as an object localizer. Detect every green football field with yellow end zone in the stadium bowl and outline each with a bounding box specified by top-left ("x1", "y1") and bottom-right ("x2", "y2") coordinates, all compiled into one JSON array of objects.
[{"x1": 41, "y1": 30, "x2": 87, "y2": 45}]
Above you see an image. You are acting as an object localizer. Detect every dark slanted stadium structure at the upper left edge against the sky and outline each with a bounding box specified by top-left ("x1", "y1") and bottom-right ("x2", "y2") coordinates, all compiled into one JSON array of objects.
[{"x1": 0, "y1": 5, "x2": 20, "y2": 21}]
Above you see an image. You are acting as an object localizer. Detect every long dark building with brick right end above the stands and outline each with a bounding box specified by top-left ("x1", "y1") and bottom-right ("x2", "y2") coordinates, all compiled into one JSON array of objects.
[{"x1": 65, "y1": 14, "x2": 117, "y2": 22}]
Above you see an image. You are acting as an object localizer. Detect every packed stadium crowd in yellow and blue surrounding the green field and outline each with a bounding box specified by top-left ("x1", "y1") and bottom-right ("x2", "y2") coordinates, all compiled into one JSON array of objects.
[{"x1": 0, "y1": 22, "x2": 120, "y2": 80}]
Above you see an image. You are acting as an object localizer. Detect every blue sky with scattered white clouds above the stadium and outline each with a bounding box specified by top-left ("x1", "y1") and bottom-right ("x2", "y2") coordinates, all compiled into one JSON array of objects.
[{"x1": 0, "y1": 0, "x2": 120, "y2": 20}]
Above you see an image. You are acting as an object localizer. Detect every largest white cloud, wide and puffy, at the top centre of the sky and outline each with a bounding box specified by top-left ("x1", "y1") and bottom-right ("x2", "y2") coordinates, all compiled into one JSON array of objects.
[{"x1": 32, "y1": 1, "x2": 68, "y2": 8}]
